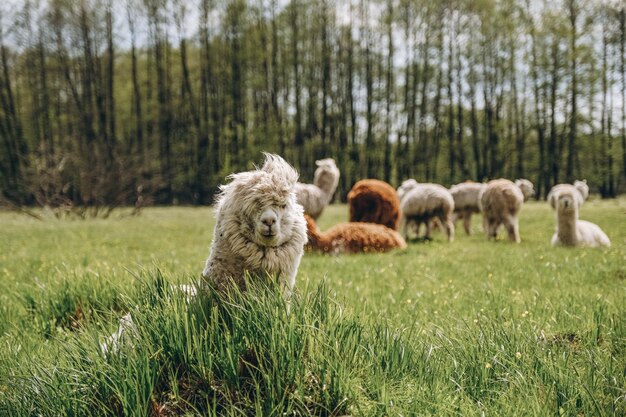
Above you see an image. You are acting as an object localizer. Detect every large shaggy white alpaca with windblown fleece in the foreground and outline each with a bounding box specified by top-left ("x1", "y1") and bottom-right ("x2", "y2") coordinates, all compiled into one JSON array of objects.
[{"x1": 202, "y1": 154, "x2": 307, "y2": 297}]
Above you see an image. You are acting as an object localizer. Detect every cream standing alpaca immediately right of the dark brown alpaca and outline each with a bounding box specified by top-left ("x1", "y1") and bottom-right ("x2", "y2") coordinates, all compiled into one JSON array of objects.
[{"x1": 398, "y1": 179, "x2": 454, "y2": 242}]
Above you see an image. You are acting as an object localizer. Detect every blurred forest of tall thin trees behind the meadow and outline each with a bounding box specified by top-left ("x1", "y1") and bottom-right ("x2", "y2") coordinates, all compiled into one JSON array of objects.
[{"x1": 0, "y1": 0, "x2": 626, "y2": 207}]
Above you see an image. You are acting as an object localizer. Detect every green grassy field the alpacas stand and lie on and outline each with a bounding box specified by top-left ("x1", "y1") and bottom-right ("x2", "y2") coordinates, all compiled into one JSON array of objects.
[{"x1": 0, "y1": 199, "x2": 626, "y2": 416}]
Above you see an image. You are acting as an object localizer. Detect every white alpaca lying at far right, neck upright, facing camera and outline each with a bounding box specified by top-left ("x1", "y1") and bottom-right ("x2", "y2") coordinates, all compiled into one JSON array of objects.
[{"x1": 552, "y1": 186, "x2": 611, "y2": 248}]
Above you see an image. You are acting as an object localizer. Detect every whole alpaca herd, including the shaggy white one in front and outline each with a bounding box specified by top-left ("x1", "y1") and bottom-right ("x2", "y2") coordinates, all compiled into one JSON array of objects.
[{"x1": 196, "y1": 154, "x2": 610, "y2": 298}]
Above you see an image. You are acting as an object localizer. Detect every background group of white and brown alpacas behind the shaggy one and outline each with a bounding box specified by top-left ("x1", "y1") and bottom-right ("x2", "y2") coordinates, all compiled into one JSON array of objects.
[{"x1": 298, "y1": 158, "x2": 610, "y2": 249}]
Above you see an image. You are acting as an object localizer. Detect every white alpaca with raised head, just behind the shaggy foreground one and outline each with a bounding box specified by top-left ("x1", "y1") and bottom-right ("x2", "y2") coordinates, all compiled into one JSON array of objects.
[{"x1": 295, "y1": 158, "x2": 339, "y2": 219}]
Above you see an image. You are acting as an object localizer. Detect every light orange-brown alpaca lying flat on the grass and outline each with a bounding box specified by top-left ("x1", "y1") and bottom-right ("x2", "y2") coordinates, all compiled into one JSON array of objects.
[{"x1": 304, "y1": 215, "x2": 406, "y2": 254}]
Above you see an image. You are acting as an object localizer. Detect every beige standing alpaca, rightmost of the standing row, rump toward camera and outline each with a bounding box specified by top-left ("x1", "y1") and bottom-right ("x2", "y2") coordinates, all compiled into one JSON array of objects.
[{"x1": 480, "y1": 179, "x2": 524, "y2": 243}]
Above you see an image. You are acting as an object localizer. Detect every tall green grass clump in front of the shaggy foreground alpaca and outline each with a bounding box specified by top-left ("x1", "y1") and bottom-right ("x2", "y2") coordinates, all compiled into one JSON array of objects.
[{"x1": 0, "y1": 274, "x2": 417, "y2": 416}]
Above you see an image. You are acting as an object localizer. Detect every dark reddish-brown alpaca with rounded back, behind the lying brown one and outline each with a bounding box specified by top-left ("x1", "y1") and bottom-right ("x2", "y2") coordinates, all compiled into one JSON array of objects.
[{"x1": 348, "y1": 180, "x2": 400, "y2": 230}]
